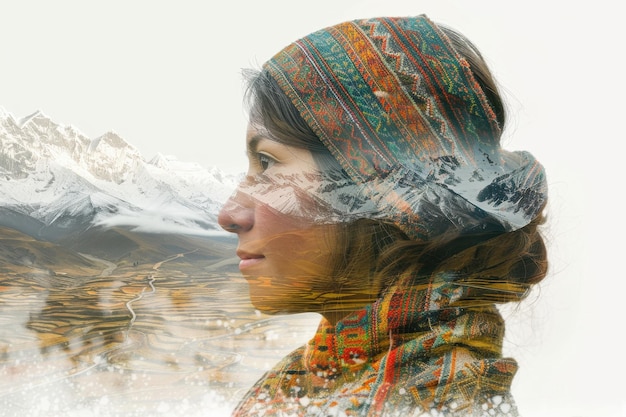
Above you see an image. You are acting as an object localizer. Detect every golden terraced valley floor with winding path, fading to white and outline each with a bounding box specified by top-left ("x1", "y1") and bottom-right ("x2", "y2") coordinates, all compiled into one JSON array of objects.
[{"x1": 0, "y1": 249, "x2": 319, "y2": 416}]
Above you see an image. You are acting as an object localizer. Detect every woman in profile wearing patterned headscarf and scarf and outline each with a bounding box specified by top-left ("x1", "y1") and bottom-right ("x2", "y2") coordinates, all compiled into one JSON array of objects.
[{"x1": 219, "y1": 16, "x2": 547, "y2": 416}]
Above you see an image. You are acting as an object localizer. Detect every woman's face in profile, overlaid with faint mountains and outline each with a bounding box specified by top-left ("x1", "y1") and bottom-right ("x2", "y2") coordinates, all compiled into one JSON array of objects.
[{"x1": 219, "y1": 125, "x2": 336, "y2": 313}]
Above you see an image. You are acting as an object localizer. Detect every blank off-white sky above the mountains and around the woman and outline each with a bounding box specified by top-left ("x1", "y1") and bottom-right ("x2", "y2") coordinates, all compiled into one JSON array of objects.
[{"x1": 0, "y1": 0, "x2": 626, "y2": 417}]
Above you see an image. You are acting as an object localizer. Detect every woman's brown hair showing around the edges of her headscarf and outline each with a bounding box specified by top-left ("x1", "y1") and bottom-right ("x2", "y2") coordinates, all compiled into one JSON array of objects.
[{"x1": 244, "y1": 27, "x2": 548, "y2": 302}]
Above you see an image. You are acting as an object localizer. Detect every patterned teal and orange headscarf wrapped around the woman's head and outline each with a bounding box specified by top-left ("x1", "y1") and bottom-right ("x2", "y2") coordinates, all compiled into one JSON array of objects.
[{"x1": 264, "y1": 15, "x2": 547, "y2": 240}]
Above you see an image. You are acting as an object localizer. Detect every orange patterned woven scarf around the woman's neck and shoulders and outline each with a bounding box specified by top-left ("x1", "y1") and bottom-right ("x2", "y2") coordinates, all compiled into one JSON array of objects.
[{"x1": 234, "y1": 274, "x2": 517, "y2": 417}]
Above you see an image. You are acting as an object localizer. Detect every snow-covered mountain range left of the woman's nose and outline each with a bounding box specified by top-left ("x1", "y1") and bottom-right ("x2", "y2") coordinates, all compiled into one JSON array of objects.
[{"x1": 0, "y1": 107, "x2": 239, "y2": 239}]
